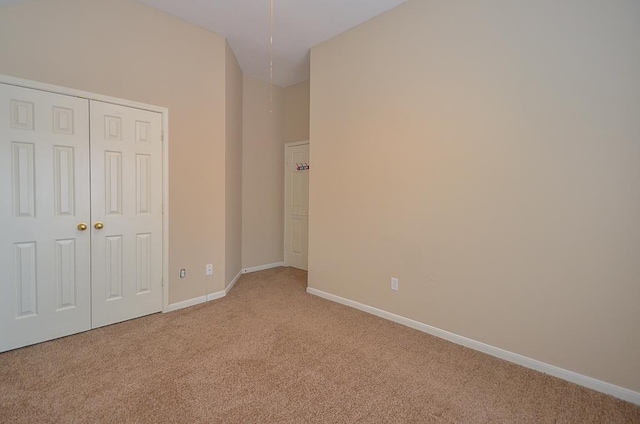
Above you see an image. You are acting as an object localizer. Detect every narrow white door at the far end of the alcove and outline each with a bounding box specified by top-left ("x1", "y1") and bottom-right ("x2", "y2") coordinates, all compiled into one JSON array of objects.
[{"x1": 284, "y1": 143, "x2": 309, "y2": 271}]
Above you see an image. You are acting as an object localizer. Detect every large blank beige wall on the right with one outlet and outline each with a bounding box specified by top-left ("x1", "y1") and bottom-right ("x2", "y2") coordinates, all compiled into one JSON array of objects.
[{"x1": 309, "y1": 0, "x2": 640, "y2": 391}]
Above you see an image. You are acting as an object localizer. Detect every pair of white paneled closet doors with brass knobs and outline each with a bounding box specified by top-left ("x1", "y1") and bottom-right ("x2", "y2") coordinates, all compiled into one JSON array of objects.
[{"x1": 0, "y1": 83, "x2": 162, "y2": 351}]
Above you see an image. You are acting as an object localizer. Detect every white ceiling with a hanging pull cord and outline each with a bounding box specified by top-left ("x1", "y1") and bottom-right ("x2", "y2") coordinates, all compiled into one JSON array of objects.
[{"x1": 0, "y1": 0, "x2": 406, "y2": 87}]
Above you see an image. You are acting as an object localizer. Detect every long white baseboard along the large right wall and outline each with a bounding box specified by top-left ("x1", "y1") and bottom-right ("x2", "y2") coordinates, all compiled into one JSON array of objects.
[{"x1": 307, "y1": 287, "x2": 640, "y2": 405}]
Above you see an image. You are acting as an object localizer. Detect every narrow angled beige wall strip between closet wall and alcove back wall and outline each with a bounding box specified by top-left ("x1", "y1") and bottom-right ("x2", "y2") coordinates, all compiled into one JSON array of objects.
[{"x1": 225, "y1": 43, "x2": 243, "y2": 285}]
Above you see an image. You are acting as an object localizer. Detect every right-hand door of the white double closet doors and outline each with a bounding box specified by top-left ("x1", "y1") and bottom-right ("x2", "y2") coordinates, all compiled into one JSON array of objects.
[{"x1": 90, "y1": 100, "x2": 162, "y2": 328}]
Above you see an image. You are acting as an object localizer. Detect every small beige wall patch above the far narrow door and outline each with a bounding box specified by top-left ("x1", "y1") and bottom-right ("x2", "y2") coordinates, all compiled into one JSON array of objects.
[{"x1": 282, "y1": 80, "x2": 311, "y2": 143}]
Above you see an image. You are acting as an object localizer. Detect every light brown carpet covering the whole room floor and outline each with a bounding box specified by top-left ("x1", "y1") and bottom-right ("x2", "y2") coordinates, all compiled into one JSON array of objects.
[{"x1": 0, "y1": 268, "x2": 640, "y2": 423}]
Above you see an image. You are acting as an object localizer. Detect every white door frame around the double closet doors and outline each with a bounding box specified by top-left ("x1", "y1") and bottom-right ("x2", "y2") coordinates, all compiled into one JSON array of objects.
[{"x1": 0, "y1": 74, "x2": 169, "y2": 312}]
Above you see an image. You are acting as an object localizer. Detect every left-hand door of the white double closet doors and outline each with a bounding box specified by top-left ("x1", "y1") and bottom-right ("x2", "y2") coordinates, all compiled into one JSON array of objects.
[{"x1": 0, "y1": 83, "x2": 91, "y2": 351}]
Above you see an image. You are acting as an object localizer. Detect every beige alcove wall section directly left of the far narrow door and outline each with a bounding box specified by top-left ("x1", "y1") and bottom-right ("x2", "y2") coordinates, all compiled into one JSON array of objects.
[{"x1": 242, "y1": 76, "x2": 284, "y2": 268}]
